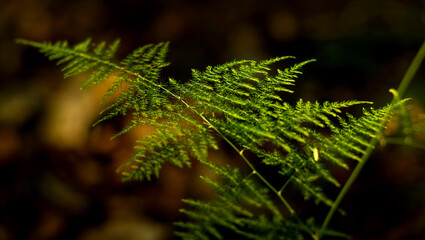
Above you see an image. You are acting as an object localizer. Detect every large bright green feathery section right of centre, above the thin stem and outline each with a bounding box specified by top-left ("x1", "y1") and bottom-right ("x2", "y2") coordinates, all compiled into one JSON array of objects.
[{"x1": 178, "y1": 57, "x2": 390, "y2": 206}]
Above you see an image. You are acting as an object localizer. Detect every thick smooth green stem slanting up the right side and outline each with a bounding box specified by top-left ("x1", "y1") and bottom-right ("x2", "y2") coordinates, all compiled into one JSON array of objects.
[{"x1": 318, "y1": 41, "x2": 425, "y2": 238}]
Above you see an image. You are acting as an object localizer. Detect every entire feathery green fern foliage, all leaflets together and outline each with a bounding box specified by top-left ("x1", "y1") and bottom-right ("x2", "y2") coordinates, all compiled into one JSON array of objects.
[{"x1": 18, "y1": 39, "x2": 418, "y2": 239}]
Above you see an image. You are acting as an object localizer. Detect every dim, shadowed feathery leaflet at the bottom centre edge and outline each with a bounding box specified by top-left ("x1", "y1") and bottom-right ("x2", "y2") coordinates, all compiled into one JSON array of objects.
[{"x1": 175, "y1": 163, "x2": 309, "y2": 239}]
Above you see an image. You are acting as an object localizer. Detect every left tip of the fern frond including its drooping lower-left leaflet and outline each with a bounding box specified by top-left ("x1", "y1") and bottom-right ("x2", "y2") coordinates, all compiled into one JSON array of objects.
[{"x1": 17, "y1": 39, "x2": 201, "y2": 182}]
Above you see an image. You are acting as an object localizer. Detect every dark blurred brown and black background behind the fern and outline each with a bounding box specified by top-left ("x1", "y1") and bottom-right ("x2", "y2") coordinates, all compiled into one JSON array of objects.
[{"x1": 0, "y1": 0, "x2": 425, "y2": 240}]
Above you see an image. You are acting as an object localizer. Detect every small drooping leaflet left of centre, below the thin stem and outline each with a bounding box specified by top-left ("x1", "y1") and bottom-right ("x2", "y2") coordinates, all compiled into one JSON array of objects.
[{"x1": 119, "y1": 122, "x2": 217, "y2": 180}]
